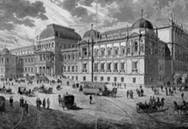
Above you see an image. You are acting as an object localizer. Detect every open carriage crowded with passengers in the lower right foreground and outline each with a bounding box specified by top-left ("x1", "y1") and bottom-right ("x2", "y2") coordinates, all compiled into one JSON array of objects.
[{"x1": 136, "y1": 98, "x2": 168, "y2": 113}]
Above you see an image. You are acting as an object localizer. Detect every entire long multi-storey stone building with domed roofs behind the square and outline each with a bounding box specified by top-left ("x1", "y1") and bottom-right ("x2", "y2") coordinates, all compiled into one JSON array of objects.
[{"x1": 1, "y1": 18, "x2": 188, "y2": 85}]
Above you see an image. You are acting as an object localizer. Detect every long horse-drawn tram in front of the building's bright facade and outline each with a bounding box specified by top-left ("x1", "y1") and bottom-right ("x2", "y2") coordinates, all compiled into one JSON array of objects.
[{"x1": 81, "y1": 82, "x2": 117, "y2": 97}]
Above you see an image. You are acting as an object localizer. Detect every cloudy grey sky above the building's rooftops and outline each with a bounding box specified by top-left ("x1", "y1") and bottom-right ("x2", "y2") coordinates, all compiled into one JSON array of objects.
[{"x1": 0, "y1": 0, "x2": 188, "y2": 48}]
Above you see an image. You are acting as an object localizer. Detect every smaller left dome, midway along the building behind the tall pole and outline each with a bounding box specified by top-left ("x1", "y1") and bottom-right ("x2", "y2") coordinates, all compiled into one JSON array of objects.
[{"x1": 83, "y1": 29, "x2": 100, "y2": 40}]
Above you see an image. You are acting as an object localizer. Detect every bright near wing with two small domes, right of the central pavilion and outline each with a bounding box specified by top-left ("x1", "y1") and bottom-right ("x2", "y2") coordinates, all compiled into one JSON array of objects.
[{"x1": 62, "y1": 18, "x2": 171, "y2": 85}]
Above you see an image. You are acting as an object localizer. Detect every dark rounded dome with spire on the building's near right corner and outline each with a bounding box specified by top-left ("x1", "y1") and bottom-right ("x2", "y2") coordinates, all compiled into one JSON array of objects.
[{"x1": 132, "y1": 18, "x2": 153, "y2": 29}]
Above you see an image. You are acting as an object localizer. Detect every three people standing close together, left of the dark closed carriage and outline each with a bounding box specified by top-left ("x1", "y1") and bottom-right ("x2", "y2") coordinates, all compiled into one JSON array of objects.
[{"x1": 36, "y1": 98, "x2": 50, "y2": 110}]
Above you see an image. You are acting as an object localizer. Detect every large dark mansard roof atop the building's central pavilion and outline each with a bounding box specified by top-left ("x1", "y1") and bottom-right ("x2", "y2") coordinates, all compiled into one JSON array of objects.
[{"x1": 39, "y1": 24, "x2": 81, "y2": 40}]
